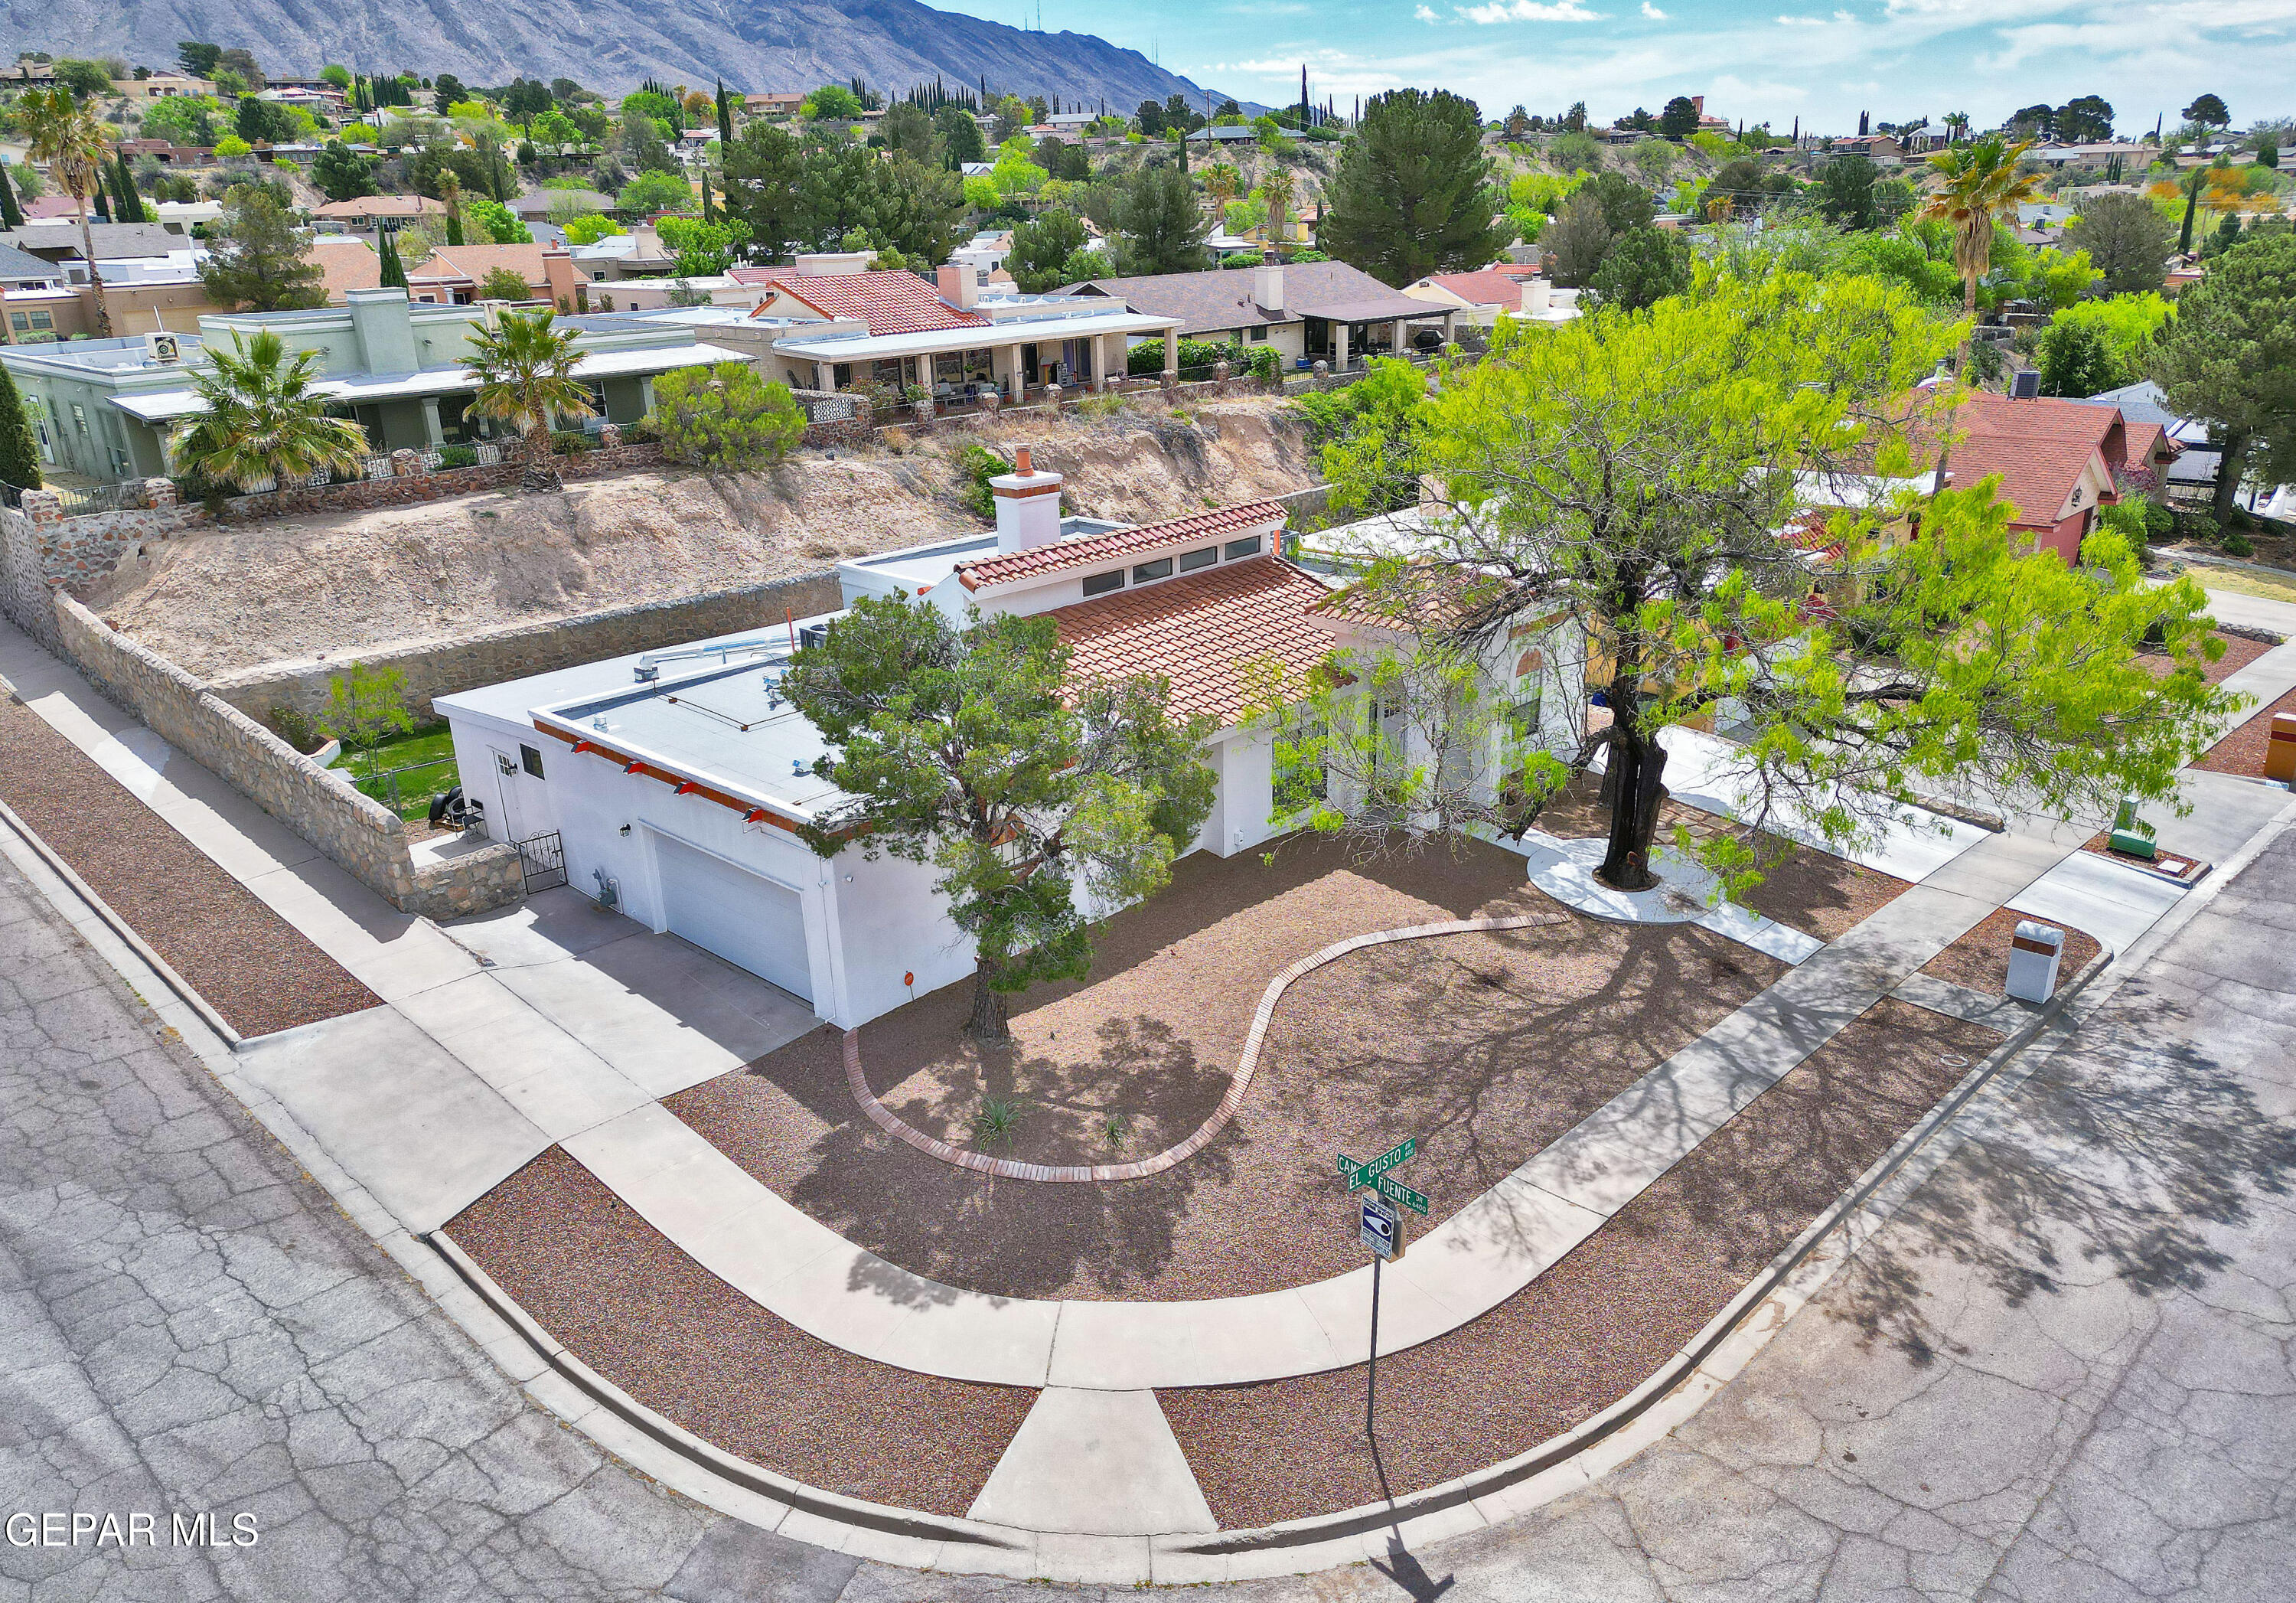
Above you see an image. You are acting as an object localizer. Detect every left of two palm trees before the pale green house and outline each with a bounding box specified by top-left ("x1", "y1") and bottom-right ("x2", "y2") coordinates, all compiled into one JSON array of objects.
[{"x1": 168, "y1": 328, "x2": 367, "y2": 496}]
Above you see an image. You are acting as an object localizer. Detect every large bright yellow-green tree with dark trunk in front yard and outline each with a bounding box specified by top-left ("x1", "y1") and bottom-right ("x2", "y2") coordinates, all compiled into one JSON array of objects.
[{"x1": 1313, "y1": 273, "x2": 2236, "y2": 891}]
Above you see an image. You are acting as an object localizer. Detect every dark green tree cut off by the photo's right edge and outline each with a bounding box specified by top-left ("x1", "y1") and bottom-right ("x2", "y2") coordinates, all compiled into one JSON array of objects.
[{"x1": 2151, "y1": 234, "x2": 2296, "y2": 519}]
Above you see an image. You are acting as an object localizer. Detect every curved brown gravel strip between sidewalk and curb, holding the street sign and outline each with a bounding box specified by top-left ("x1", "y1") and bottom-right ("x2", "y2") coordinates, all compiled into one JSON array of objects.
[{"x1": 1157, "y1": 1001, "x2": 2000, "y2": 1530}]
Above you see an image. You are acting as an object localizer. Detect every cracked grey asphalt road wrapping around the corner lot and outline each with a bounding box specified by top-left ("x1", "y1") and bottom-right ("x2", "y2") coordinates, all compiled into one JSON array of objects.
[{"x1": 0, "y1": 834, "x2": 2296, "y2": 1603}]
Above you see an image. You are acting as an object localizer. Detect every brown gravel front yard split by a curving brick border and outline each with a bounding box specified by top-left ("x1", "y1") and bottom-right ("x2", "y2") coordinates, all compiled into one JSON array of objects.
[{"x1": 668, "y1": 841, "x2": 1782, "y2": 1298}]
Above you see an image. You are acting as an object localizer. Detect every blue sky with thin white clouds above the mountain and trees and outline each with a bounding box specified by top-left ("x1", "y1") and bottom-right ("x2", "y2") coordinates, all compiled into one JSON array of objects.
[{"x1": 930, "y1": 0, "x2": 2296, "y2": 133}]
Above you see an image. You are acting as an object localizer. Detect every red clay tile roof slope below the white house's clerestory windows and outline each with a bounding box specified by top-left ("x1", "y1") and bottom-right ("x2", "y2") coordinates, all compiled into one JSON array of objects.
[{"x1": 1047, "y1": 556, "x2": 1332, "y2": 726}]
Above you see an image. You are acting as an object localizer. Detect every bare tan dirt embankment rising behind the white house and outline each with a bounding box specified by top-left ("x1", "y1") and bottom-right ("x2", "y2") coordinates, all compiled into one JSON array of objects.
[{"x1": 80, "y1": 397, "x2": 1320, "y2": 675}]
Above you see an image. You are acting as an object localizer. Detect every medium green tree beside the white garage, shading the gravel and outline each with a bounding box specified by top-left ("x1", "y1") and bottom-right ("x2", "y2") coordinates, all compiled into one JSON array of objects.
[{"x1": 781, "y1": 597, "x2": 1215, "y2": 1040}]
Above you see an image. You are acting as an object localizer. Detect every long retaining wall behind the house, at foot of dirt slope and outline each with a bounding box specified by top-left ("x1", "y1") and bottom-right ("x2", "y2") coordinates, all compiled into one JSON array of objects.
[{"x1": 209, "y1": 572, "x2": 843, "y2": 719}]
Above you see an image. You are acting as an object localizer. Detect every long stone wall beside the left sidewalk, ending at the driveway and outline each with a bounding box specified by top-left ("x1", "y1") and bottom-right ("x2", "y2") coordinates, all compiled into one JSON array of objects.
[{"x1": 55, "y1": 595, "x2": 526, "y2": 919}]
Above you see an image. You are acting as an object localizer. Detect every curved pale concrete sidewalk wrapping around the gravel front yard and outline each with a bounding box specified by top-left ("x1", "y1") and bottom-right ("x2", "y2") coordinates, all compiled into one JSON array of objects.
[{"x1": 565, "y1": 818, "x2": 2103, "y2": 1392}]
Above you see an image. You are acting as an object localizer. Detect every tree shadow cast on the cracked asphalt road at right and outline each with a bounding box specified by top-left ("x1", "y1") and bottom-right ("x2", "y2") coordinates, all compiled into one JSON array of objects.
[{"x1": 1809, "y1": 988, "x2": 2296, "y2": 1364}]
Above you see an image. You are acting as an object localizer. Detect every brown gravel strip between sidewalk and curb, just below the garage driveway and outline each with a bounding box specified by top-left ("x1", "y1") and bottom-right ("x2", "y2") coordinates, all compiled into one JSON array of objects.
[{"x1": 448, "y1": 1146, "x2": 1035, "y2": 1516}]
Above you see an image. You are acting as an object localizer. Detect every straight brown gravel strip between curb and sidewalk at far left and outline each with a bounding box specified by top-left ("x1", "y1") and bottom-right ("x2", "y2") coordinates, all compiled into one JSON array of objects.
[{"x1": 0, "y1": 700, "x2": 381, "y2": 1036}]
